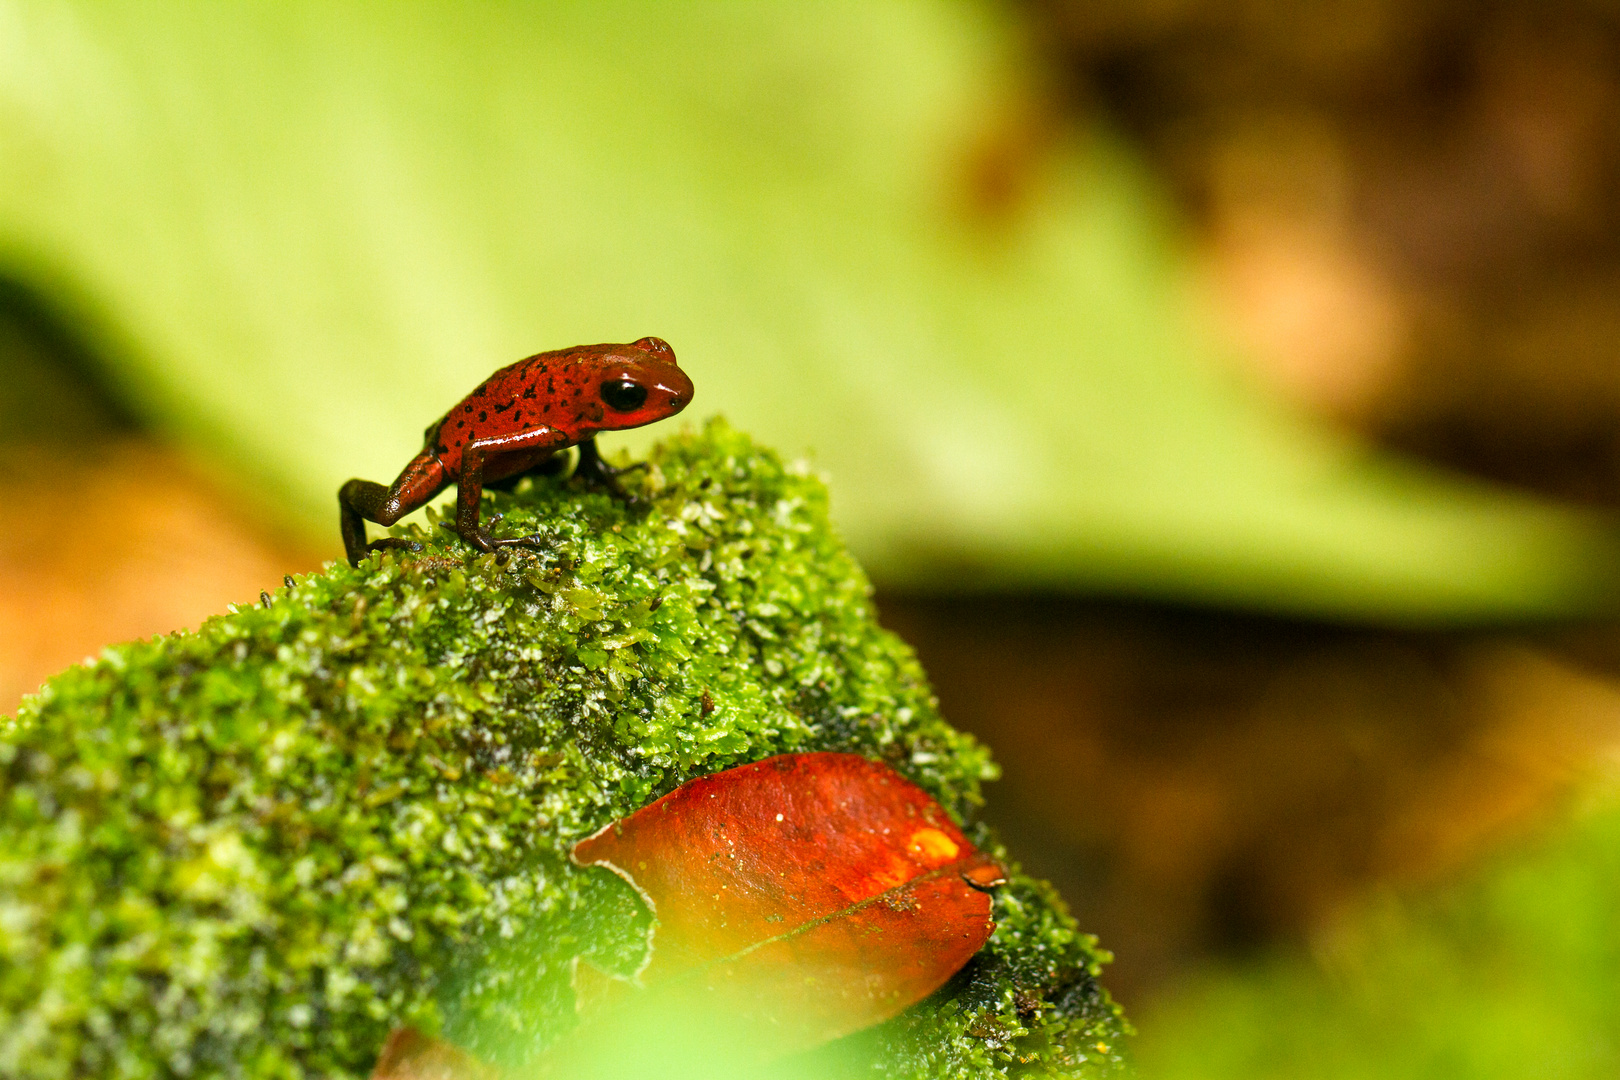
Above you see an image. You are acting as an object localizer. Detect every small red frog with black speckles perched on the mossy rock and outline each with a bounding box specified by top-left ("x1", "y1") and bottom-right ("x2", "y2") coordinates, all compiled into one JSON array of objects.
[{"x1": 337, "y1": 337, "x2": 692, "y2": 567}]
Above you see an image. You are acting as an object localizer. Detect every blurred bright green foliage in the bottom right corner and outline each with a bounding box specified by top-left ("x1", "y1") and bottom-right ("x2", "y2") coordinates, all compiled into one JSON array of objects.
[{"x1": 1137, "y1": 787, "x2": 1620, "y2": 1080}]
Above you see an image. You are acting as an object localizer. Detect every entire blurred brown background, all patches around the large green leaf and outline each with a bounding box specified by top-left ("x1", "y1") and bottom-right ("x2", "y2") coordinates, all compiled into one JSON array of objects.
[{"x1": 0, "y1": 0, "x2": 1620, "y2": 1006}]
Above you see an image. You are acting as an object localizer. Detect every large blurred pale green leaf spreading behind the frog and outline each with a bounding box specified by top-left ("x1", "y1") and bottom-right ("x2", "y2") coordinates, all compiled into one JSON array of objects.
[{"x1": 0, "y1": 0, "x2": 1617, "y2": 619}]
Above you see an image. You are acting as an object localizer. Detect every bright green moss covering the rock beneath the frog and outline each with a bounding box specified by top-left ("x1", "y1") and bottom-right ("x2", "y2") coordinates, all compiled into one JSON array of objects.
[{"x1": 0, "y1": 423, "x2": 1124, "y2": 1078}]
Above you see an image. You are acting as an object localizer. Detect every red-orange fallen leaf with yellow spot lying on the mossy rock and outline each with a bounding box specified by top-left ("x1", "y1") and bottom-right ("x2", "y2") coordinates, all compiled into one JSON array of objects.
[{"x1": 573, "y1": 753, "x2": 1004, "y2": 1051}]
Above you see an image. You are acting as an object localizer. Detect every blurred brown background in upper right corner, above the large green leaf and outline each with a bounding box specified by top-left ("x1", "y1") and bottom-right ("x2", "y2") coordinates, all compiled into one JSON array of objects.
[{"x1": 1027, "y1": 0, "x2": 1620, "y2": 505}]
